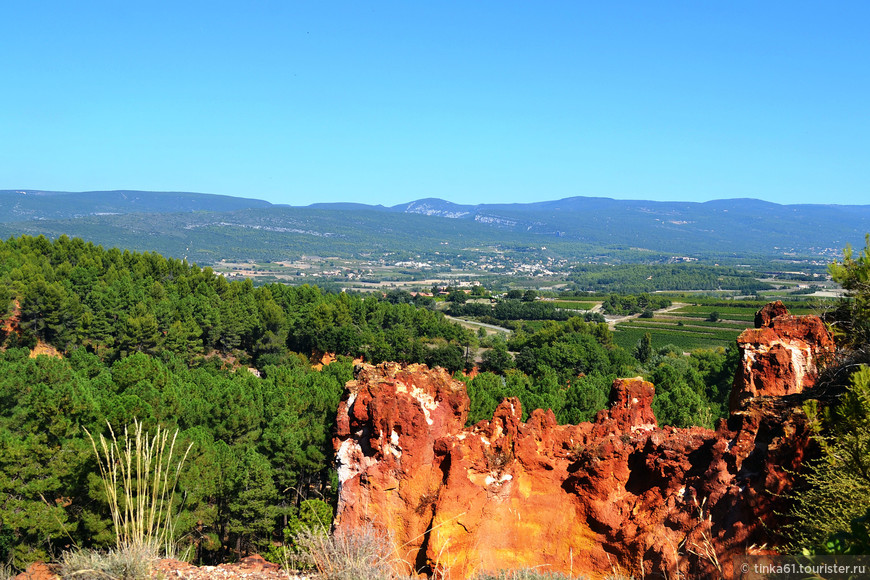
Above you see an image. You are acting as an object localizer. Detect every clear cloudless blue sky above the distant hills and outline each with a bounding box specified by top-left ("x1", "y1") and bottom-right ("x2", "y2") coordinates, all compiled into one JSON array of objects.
[{"x1": 0, "y1": 0, "x2": 870, "y2": 205}]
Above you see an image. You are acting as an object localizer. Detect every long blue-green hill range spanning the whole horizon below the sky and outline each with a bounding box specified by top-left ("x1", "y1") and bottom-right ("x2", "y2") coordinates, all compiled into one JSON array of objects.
[{"x1": 0, "y1": 190, "x2": 870, "y2": 263}]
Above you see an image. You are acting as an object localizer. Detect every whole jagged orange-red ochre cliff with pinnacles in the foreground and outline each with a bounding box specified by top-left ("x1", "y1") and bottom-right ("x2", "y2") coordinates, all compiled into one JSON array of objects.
[{"x1": 334, "y1": 303, "x2": 834, "y2": 580}]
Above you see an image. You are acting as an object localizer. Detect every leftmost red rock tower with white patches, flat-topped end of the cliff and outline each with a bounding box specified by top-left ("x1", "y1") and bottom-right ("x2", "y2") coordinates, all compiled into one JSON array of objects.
[{"x1": 336, "y1": 363, "x2": 468, "y2": 568}]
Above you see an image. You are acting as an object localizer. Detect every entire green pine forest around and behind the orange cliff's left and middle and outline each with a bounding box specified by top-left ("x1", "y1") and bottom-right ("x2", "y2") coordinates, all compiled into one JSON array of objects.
[{"x1": 0, "y1": 236, "x2": 733, "y2": 567}]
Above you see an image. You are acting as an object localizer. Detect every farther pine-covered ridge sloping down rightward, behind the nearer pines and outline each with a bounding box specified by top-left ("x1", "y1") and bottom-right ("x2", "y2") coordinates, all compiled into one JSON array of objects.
[{"x1": 0, "y1": 236, "x2": 476, "y2": 366}]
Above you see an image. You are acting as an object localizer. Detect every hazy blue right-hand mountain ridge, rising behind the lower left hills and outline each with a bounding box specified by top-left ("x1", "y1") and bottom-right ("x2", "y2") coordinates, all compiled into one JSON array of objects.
[{"x1": 336, "y1": 197, "x2": 870, "y2": 253}]
